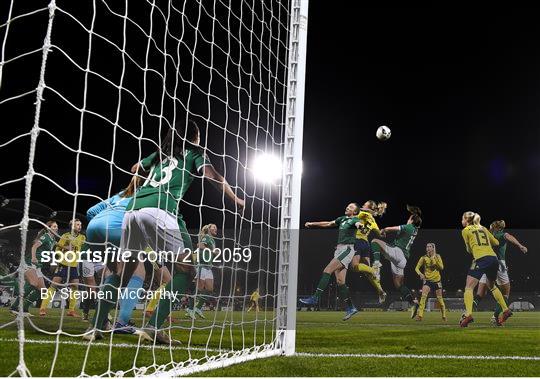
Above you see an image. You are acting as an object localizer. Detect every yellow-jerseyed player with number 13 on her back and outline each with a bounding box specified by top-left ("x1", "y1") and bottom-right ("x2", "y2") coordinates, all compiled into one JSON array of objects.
[{"x1": 459, "y1": 212, "x2": 512, "y2": 327}]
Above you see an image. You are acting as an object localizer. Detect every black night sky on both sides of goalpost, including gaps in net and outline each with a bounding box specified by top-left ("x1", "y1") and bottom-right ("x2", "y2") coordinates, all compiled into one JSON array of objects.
[{"x1": 0, "y1": 0, "x2": 540, "y2": 285}]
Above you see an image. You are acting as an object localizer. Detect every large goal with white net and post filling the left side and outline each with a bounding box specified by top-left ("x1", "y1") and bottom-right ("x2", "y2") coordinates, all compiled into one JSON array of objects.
[{"x1": 0, "y1": 0, "x2": 307, "y2": 376}]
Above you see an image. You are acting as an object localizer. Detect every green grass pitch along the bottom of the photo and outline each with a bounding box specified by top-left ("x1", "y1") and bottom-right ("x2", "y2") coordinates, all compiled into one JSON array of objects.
[{"x1": 0, "y1": 308, "x2": 540, "y2": 376}]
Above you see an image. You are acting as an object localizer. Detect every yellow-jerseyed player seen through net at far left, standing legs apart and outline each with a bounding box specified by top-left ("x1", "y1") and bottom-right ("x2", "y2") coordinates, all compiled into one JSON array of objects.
[{"x1": 39, "y1": 218, "x2": 86, "y2": 317}]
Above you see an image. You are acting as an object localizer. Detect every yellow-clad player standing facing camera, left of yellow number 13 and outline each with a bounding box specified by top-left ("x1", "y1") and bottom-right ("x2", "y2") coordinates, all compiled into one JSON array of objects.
[{"x1": 415, "y1": 242, "x2": 446, "y2": 321}]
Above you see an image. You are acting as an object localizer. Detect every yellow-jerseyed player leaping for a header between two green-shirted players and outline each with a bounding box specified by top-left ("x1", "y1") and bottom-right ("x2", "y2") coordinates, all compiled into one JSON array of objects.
[{"x1": 351, "y1": 200, "x2": 387, "y2": 304}]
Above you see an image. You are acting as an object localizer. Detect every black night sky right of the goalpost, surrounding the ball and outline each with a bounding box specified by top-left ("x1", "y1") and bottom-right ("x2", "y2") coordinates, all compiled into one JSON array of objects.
[{"x1": 301, "y1": 5, "x2": 540, "y2": 228}]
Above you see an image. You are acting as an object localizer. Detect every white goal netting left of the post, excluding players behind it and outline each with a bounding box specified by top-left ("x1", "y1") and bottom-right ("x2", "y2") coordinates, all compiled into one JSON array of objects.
[{"x1": 0, "y1": 0, "x2": 306, "y2": 376}]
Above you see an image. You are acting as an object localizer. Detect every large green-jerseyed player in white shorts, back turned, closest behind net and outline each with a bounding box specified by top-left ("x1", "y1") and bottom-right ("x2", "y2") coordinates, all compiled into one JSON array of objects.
[{"x1": 84, "y1": 120, "x2": 244, "y2": 343}]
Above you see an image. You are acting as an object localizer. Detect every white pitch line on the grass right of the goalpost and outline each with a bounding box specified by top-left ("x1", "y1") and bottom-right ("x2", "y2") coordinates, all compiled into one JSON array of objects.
[{"x1": 295, "y1": 353, "x2": 540, "y2": 361}]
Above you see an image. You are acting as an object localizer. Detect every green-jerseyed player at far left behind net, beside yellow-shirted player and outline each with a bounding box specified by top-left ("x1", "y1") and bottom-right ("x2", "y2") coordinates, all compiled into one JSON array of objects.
[{"x1": 11, "y1": 220, "x2": 58, "y2": 316}]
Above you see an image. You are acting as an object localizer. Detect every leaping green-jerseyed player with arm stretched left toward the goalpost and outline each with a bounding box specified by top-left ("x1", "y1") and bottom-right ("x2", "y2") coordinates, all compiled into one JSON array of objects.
[{"x1": 300, "y1": 203, "x2": 360, "y2": 321}]
